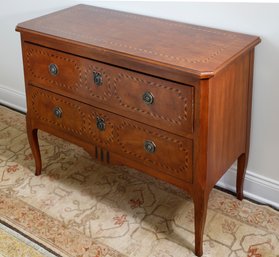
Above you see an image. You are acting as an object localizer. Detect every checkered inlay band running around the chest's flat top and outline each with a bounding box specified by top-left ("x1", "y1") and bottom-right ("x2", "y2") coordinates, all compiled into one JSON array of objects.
[{"x1": 22, "y1": 5, "x2": 238, "y2": 64}]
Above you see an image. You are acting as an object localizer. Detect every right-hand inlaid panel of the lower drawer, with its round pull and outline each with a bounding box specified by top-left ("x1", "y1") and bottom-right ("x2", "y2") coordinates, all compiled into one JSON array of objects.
[{"x1": 115, "y1": 119, "x2": 192, "y2": 182}]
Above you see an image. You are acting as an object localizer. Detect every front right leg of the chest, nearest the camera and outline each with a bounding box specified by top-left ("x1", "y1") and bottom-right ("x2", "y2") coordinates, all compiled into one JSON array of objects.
[{"x1": 194, "y1": 189, "x2": 209, "y2": 257}]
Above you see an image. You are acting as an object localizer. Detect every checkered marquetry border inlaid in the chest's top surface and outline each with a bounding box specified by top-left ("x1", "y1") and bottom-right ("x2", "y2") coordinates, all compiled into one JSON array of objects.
[{"x1": 25, "y1": 6, "x2": 238, "y2": 64}]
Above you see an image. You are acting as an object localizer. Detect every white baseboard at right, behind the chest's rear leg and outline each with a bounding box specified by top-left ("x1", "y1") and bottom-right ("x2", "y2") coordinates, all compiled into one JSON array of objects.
[{"x1": 217, "y1": 166, "x2": 279, "y2": 209}]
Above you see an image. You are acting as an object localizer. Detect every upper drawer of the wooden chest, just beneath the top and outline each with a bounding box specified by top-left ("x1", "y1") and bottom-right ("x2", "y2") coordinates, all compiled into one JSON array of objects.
[{"x1": 23, "y1": 43, "x2": 193, "y2": 136}]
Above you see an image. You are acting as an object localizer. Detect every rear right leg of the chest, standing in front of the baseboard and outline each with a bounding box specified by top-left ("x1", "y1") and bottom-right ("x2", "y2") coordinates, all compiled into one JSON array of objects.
[{"x1": 236, "y1": 153, "x2": 248, "y2": 200}]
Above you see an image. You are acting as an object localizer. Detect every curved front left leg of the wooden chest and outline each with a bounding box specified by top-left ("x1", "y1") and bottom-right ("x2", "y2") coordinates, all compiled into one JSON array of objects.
[{"x1": 26, "y1": 117, "x2": 42, "y2": 176}]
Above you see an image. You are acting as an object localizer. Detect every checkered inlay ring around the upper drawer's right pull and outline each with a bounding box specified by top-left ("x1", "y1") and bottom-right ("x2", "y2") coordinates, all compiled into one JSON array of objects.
[{"x1": 114, "y1": 73, "x2": 191, "y2": 125}]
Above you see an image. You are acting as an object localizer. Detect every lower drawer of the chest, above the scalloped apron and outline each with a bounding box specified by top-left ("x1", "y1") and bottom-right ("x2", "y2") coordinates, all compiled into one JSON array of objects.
[{"x1": 28, "y1": 86, "x2": 192, "y2": 182}]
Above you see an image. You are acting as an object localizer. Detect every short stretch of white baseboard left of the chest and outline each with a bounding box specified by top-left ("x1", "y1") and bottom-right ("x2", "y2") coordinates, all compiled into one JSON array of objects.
[{"x1": 0, "y1": 84, "x2": 26, "y2": 112}]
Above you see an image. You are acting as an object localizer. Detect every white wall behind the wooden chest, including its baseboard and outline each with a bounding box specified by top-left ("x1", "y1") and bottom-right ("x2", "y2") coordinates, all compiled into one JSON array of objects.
[{"x1": 0, "y1": 0, "x2": 279, "y2": 206}]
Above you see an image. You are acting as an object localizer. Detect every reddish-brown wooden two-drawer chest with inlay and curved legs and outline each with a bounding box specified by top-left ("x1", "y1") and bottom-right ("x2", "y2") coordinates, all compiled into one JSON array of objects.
[{"x1": 17, "y1": 5, "x2": 260, "y2": 256}]
